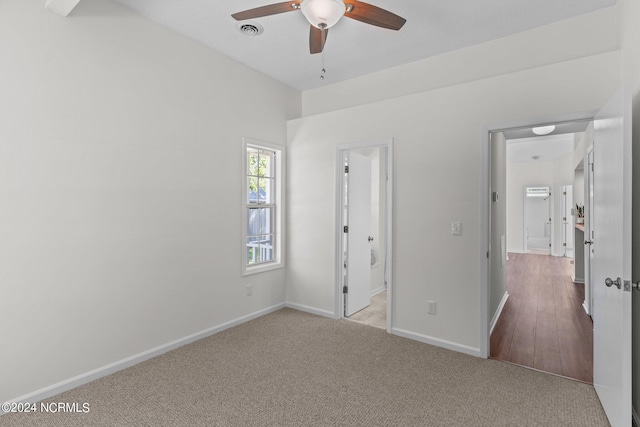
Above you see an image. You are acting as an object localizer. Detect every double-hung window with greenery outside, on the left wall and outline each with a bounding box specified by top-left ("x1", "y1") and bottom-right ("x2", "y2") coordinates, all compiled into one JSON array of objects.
[{"x1": 242, "y1": 138, "x2": 284, "y2": 275}]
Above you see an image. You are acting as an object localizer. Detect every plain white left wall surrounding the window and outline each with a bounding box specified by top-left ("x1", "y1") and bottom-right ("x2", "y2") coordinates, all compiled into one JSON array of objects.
[{"x1": 0, "y1": 0, "x2": 300, "y2": 401}]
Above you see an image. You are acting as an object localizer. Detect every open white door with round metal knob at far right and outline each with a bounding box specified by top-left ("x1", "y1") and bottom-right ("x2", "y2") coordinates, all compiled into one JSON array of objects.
[{"x1": 591, "y1": 90, "x2": 631, "y2": 427}]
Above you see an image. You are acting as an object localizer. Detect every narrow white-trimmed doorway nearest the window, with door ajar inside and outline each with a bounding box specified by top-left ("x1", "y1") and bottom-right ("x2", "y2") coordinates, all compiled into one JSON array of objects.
[{"x1": 335, "y1": 139, "x2": 393, "y2": 331}]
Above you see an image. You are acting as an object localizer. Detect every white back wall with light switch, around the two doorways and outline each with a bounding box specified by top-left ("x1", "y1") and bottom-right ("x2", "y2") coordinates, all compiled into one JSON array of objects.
[{"x1": 287, "y1": 52, "x2": 620, "y2": 353}]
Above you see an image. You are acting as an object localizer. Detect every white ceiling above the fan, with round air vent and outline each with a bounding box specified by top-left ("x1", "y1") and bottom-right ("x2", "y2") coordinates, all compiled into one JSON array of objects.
[{"x1": 109, "y1": 0, "x2": 616, "y2": 90}]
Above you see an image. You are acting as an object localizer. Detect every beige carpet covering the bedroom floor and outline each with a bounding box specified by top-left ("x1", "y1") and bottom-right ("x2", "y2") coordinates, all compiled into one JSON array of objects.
[{"x1": 0, "y1": 309, "x2": 608, "y2": 427}]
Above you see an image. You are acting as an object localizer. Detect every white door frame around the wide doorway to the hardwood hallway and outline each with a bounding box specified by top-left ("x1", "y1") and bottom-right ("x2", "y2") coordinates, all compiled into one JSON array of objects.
[{"x1": 479, "y1": 110, "x2": 597, "y2": 359}]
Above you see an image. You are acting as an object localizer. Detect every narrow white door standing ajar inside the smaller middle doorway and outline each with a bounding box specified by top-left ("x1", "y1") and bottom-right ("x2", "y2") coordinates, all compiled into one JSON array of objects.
[{"x1": 344, "y1": 152, "x2": 371, "y2": 317}]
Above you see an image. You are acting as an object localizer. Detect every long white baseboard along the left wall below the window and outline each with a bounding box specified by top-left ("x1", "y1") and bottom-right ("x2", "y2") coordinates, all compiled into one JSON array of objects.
[{"x1": 0, "y1": 303, "x2": 285, "y2": 415}]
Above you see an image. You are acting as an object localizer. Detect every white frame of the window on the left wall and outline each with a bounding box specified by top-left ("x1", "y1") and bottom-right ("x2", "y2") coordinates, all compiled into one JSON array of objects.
[{"x1": 241, "y1": 138, "x2": 286, "y2": 276}]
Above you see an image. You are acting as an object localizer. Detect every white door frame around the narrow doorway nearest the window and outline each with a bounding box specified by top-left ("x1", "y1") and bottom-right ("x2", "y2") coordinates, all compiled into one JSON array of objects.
[{"x1": 334, "y1": 138, "x2": 393, "y2": 332}]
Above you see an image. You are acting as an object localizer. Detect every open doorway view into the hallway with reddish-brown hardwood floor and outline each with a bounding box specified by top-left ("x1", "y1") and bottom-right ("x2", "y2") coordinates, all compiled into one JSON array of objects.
[{"x1": 488, "y1": 120, "x2": 593, "y2": 383}]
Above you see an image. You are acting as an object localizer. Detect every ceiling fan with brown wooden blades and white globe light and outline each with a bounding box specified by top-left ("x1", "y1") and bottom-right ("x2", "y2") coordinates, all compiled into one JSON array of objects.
[{"x1": 231, "y1": 0, "x2": 407, "y2": 54}]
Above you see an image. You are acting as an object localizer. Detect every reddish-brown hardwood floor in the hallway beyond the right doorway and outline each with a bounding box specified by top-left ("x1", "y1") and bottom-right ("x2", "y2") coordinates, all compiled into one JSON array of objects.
[{"x1": 490, "y1": 253, "x2": 593, "y2": 383}]
